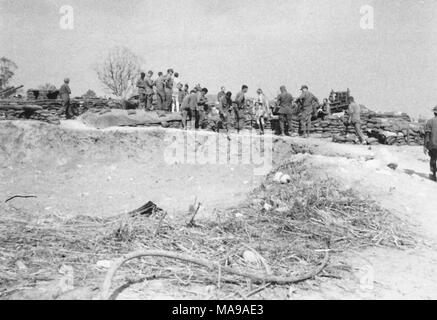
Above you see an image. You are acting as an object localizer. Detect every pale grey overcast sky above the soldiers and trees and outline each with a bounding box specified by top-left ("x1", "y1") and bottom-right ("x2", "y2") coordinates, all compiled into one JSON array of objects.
[{"x1": 0, "y1": 0, "x2": 437, "y2": 116}]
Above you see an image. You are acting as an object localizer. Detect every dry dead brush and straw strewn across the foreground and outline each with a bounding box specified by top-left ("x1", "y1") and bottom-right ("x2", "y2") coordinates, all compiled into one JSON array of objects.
[{"x1": 0, "y1": 162, "x2": 414, "y2": 298}]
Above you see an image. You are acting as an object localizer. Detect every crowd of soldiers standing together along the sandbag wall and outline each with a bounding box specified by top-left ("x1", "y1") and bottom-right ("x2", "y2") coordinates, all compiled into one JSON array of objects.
[{"x1": 137, "y1": 69, "x2": 366, "y2": 143}]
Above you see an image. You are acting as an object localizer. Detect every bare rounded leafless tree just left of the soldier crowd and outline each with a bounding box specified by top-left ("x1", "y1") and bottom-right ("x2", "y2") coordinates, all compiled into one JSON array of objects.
[{"x1": 96, "y1": 47, "x2": 141, "y2": 98}]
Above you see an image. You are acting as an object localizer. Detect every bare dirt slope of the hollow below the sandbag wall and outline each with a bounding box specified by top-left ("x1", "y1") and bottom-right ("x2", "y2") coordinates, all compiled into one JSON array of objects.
[{"x1": 0, "y1": 121, "x2": 306, "y2": 216}]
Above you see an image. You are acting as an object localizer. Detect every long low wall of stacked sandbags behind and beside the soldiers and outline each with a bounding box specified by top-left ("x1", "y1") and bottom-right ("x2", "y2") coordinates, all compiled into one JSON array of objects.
[{"x1": 0, "y1": 96, "x2": 425, "y2": 145}]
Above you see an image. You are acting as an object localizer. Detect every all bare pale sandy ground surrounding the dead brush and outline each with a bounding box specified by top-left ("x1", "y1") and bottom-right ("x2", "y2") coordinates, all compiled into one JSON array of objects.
[{"x1": 0, "y1": 121, "x2": 437, "y2": 299}]
